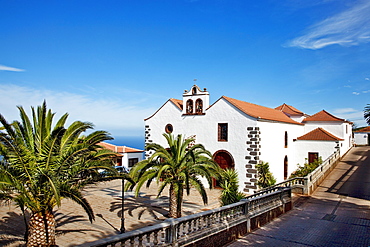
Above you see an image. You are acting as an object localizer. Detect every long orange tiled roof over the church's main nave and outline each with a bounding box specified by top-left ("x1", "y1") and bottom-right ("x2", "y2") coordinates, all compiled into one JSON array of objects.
[{"x1": 222, "y1": 96, "x2": 302, "y2": 125}]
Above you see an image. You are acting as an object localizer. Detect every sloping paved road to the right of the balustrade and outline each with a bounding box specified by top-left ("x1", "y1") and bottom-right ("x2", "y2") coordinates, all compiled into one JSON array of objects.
[{"x1": 228, "y1": 146, "x2": 370, "y2": 247}]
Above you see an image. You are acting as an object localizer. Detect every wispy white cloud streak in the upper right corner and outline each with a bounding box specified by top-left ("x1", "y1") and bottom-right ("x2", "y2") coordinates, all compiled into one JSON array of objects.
[{"x1": 288, "y1": 1, "x2": 370, "y2": 50}]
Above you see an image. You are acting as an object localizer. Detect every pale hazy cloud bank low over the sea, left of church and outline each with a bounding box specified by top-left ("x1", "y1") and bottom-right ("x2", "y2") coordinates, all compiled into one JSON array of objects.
[{"x1": 0, "y1": 85, "x2": 156, "y2": 136}]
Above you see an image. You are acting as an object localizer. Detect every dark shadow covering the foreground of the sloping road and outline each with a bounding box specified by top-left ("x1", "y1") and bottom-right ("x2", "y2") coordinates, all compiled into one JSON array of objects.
[{"x1": 228, "y1": 197, "x2": 370, "y2": 247}]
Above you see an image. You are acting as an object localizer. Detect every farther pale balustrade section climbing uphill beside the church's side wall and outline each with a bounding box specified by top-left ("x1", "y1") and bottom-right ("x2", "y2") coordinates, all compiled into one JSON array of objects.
[{"x1": 257, "y1": 151, "x2": 340, "y2": 195}]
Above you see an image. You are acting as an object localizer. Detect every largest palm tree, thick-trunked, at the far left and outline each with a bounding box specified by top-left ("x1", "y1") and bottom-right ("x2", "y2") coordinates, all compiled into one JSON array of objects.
[{"x1": 0, "y1": 101, "x2": 115, "y2": 246}]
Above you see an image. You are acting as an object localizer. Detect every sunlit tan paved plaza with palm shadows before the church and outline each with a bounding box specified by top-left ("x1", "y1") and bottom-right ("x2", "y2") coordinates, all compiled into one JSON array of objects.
[{"x1": 0, "y1": 180, "x2": 221, "y2": 247}]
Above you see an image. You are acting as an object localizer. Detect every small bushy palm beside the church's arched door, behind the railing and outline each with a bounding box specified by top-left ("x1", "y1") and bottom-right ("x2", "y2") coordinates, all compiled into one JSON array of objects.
[{"x1": 220, "y1": 169, "x2": 246, "y2": 206}]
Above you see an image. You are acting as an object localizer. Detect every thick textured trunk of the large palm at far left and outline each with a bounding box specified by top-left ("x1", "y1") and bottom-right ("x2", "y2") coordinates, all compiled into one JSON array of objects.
[{"x1": 27, "y1": 211, "x2": 55, "y2": 247}]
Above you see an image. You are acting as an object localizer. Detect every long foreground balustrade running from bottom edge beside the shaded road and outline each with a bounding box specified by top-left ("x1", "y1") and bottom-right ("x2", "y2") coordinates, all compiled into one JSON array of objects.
[{"x1": 80, "y1": 187, "x2": 292, "y2": 247}]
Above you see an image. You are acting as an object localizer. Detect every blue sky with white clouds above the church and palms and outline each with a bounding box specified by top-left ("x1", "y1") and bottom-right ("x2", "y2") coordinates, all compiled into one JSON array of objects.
[{"x1": 0, "y1": 0, "x2": 370, "y2": 146}]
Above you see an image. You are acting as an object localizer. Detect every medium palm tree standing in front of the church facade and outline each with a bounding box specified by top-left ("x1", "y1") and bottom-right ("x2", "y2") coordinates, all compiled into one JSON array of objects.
[{"x1": 130, "y1": 134, "x2": 219, "y2": 218}]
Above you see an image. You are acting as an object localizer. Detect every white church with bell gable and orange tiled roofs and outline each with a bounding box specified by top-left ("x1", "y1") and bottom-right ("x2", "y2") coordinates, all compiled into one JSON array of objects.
[{"x1": 145, "y1": 85, "x2": 353, "y2": 193}]
